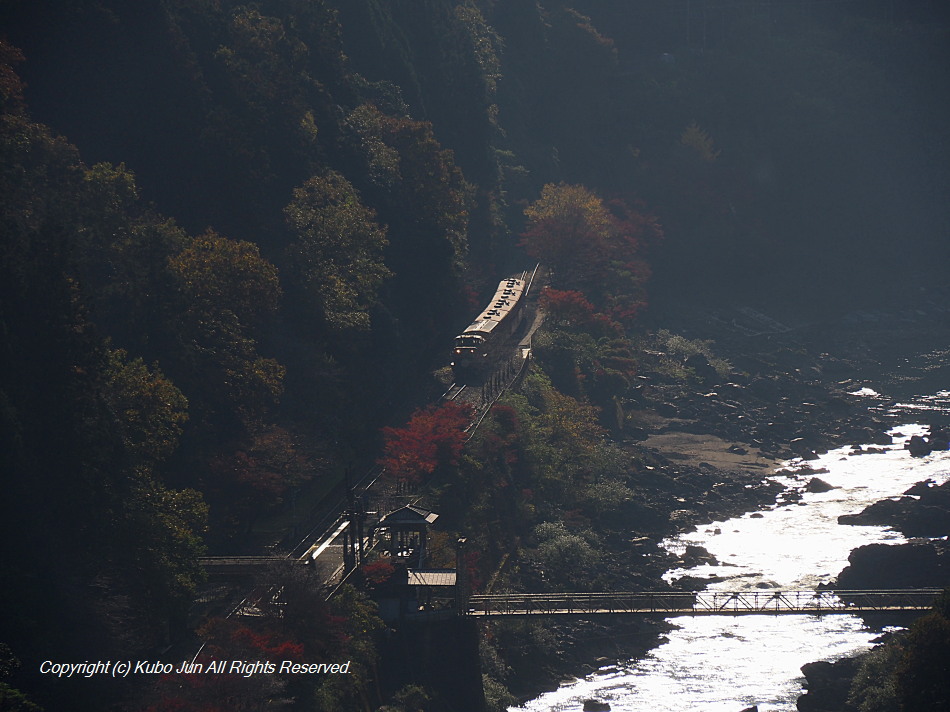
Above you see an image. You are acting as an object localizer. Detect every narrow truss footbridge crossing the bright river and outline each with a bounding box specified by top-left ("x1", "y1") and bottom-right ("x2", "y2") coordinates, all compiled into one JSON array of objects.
[{"x1": 460, "y1": 588, "x2": 941, "y2": 618}]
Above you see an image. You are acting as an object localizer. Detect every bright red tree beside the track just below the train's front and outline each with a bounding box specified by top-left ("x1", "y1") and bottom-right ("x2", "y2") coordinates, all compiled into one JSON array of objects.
[{"x1": 379, "y1": 402, "x2": 472, "y2": 482}]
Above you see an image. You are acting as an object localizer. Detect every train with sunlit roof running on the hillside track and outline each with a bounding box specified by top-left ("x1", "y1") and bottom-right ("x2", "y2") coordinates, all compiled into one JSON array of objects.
[{"x1": 452, "y1": 277, "x2": 525, "y2": 380}]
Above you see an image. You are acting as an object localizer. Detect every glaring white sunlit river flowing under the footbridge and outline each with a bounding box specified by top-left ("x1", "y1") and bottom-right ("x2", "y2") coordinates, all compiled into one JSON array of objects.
[{"x1": 511, "y1": 389, "x2": 950, "y2": 712}]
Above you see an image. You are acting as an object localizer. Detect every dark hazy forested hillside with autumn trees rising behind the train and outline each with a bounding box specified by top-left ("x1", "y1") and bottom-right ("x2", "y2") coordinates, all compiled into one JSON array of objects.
[{"x1": 0, "y1": 0, "x2": 950, "y2": 709}]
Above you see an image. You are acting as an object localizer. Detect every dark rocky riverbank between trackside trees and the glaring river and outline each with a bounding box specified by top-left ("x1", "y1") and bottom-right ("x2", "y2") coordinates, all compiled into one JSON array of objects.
[{"x1": 508, "y1": 300, "x2": 950, "y2": 704}]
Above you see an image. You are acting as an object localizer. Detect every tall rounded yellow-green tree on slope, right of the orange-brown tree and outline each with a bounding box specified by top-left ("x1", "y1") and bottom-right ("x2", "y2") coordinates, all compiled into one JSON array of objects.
[{"x1": 284, "y1": 171, "x2": 390, "y2": 331}]
